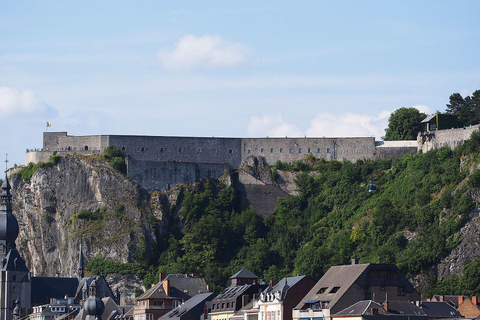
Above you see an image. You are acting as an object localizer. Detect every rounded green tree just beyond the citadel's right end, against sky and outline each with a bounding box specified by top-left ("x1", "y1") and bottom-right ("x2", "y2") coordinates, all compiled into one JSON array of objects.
[{"x1": 384, "y1": 108, "x2": 426, "y2": 141}]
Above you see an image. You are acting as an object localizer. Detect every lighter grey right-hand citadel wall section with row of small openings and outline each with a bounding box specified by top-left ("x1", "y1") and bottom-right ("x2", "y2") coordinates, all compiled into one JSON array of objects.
[{"x1": 242, "y1": 137, "x2": 375, "y2": 165}]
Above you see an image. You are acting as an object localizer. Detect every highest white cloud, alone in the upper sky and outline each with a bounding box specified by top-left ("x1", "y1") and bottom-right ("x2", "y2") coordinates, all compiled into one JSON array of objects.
[{"x1": 160, "y1": 35, "x2": 253, "y2": 71}]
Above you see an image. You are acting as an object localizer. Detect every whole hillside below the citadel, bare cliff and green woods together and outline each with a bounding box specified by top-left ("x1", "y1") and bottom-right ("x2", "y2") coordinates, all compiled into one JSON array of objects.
[{"x1": 11, "y1": 134, "x2": 480, "y2": 294}]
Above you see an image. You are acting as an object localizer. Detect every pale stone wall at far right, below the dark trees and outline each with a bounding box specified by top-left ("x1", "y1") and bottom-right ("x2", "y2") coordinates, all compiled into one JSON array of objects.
[{"x1": 417, "y1": 125, "x2": 480, "y2": 152}]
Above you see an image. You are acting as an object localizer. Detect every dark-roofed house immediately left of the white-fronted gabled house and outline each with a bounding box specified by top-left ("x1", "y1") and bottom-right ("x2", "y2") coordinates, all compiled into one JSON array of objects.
[{"x1": 209, "y1": 269, "x2": 267, "y2": 320}]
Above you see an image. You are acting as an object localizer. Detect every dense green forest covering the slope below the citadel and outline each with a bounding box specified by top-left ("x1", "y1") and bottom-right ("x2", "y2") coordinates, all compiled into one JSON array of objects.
[{"x1": 88, "y1": 129, "x2": 480, "y2": 296}]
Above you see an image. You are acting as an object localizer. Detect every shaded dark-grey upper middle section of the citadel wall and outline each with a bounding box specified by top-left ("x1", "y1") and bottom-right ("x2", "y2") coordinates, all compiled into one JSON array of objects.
[{"x1": 109, "y1": 136, "x2": 241, "y2": 168}]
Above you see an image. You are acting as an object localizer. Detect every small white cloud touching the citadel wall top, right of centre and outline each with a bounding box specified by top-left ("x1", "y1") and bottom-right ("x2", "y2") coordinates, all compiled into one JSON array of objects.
[{"x1": 247, "y1": 115, "x2": 303, "y2": 137}]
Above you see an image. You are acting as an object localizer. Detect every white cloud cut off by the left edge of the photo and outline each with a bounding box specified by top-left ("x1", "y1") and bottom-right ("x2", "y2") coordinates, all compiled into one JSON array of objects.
[{"x1": 0, "y1": 87, "x2": 57, "y2": 118}]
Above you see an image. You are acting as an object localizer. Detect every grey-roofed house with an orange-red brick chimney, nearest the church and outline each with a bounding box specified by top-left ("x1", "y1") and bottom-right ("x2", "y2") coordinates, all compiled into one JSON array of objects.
[{"x1": 133, "y1": 273, "x2": 209, "y2": 320}]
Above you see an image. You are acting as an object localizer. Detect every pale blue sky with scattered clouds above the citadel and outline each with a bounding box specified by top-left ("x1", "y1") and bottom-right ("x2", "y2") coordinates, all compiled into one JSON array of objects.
[{"x1": 0, "y1": 0, "x2": 480, "y2": 167}]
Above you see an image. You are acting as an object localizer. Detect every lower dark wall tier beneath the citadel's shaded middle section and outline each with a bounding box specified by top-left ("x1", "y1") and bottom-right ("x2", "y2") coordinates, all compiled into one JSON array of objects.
[{"x1": 127, "y1": 158, "x2": 228, "y2": 190}]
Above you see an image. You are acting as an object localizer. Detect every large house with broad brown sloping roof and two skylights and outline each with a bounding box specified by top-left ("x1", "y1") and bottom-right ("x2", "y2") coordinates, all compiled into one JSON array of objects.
[{"x1": 293, "y1": 261, "x2": 420, "y2": 320}]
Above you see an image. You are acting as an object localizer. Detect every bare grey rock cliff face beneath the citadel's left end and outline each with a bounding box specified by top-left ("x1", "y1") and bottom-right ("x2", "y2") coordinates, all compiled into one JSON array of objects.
[{"x1": 10, "y1": 156, "x2": 166, "y2": 276}]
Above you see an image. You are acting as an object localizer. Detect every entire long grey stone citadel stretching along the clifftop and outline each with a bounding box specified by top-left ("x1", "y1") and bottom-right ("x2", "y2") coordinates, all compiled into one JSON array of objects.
[{"x1": 25, "y1": 132, "x2": 417, "y2": 190}]
